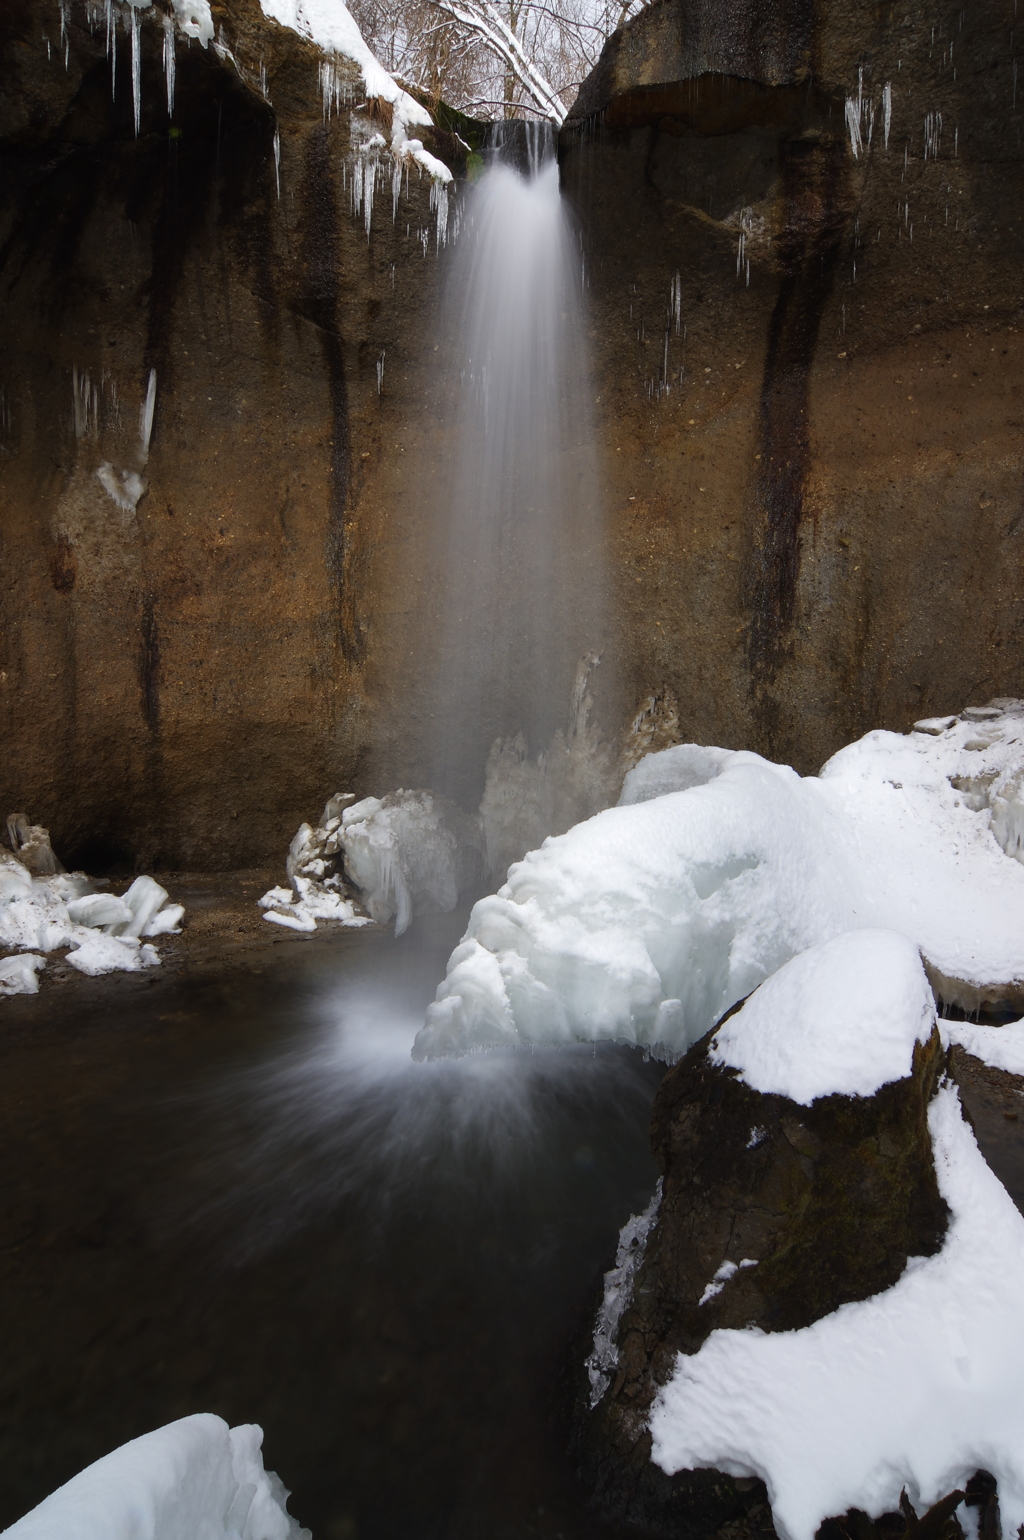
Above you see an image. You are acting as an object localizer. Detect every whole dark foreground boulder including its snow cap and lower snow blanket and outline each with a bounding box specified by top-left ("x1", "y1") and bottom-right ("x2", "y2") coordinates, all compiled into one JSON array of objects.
[{"x1": 581, "y1": 930, "x2": 1024, "y2": 1540}]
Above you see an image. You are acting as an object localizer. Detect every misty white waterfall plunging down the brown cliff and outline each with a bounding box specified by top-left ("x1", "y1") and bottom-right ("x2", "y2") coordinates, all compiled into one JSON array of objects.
[{"x1": 431, "y1": 123, "x2": 604, "y2": 832}]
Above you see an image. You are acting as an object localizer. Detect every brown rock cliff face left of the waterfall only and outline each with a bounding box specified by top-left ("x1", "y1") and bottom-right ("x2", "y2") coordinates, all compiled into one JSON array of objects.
[{"x1": 0, "y1": 0, "x2": 459, "y2": 870}]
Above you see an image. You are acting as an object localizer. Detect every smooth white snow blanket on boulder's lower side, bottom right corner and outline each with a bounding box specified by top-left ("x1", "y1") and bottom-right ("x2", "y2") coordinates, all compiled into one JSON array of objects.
[{"x1": 650, "y1": 1086, "x2": 1024, "y2": 1540}]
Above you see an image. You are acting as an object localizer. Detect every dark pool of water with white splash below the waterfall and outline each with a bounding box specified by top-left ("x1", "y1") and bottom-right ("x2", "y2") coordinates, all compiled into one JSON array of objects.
[{"x1": 0, "y1": 916, "x2": 661, "y2": 1540}]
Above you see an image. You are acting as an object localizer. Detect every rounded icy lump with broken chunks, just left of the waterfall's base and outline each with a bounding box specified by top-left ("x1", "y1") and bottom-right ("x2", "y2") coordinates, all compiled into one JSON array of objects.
[{"x1": 259, "y1": 790, "x2": 482, "y2": 936}]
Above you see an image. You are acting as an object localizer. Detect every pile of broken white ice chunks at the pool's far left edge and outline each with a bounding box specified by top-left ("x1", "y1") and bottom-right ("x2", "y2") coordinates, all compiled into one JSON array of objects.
[{"x1": 0, "y1": 813, "x2": 185, "y2": 995}]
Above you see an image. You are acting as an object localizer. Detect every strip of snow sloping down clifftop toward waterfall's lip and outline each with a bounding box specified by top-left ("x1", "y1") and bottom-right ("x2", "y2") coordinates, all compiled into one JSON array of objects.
[{"x1": 260, "y1": 0, "x2": 451, "y2": 188}]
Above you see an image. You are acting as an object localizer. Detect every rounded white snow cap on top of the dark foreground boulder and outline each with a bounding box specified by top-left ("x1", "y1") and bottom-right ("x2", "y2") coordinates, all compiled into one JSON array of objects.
[{"x1": 710, "y1": 930, "x2": 935, "y2": 1107}]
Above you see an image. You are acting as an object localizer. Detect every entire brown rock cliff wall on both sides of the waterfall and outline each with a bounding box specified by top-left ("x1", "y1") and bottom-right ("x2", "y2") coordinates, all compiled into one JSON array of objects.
[{"x1": 0, "y1": 0, "x2": 1024, "y2": 870}]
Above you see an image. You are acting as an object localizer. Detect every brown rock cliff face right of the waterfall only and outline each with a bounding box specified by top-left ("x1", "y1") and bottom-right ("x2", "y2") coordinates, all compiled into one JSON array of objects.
[{"x1": 564, "y1": 0, "x2": 1024, "y2": 770}]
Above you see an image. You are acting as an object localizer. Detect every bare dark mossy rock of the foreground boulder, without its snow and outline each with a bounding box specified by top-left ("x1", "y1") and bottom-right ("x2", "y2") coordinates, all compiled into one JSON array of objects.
[{"x1": 579, "y1": 1007, "x2": 947, "y2": 1540}]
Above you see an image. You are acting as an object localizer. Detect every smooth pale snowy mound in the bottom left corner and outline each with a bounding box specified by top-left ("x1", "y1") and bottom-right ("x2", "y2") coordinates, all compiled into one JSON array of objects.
[{"x1": 5, "y1": 1412, "x2": 310, "y2": 1540}]
